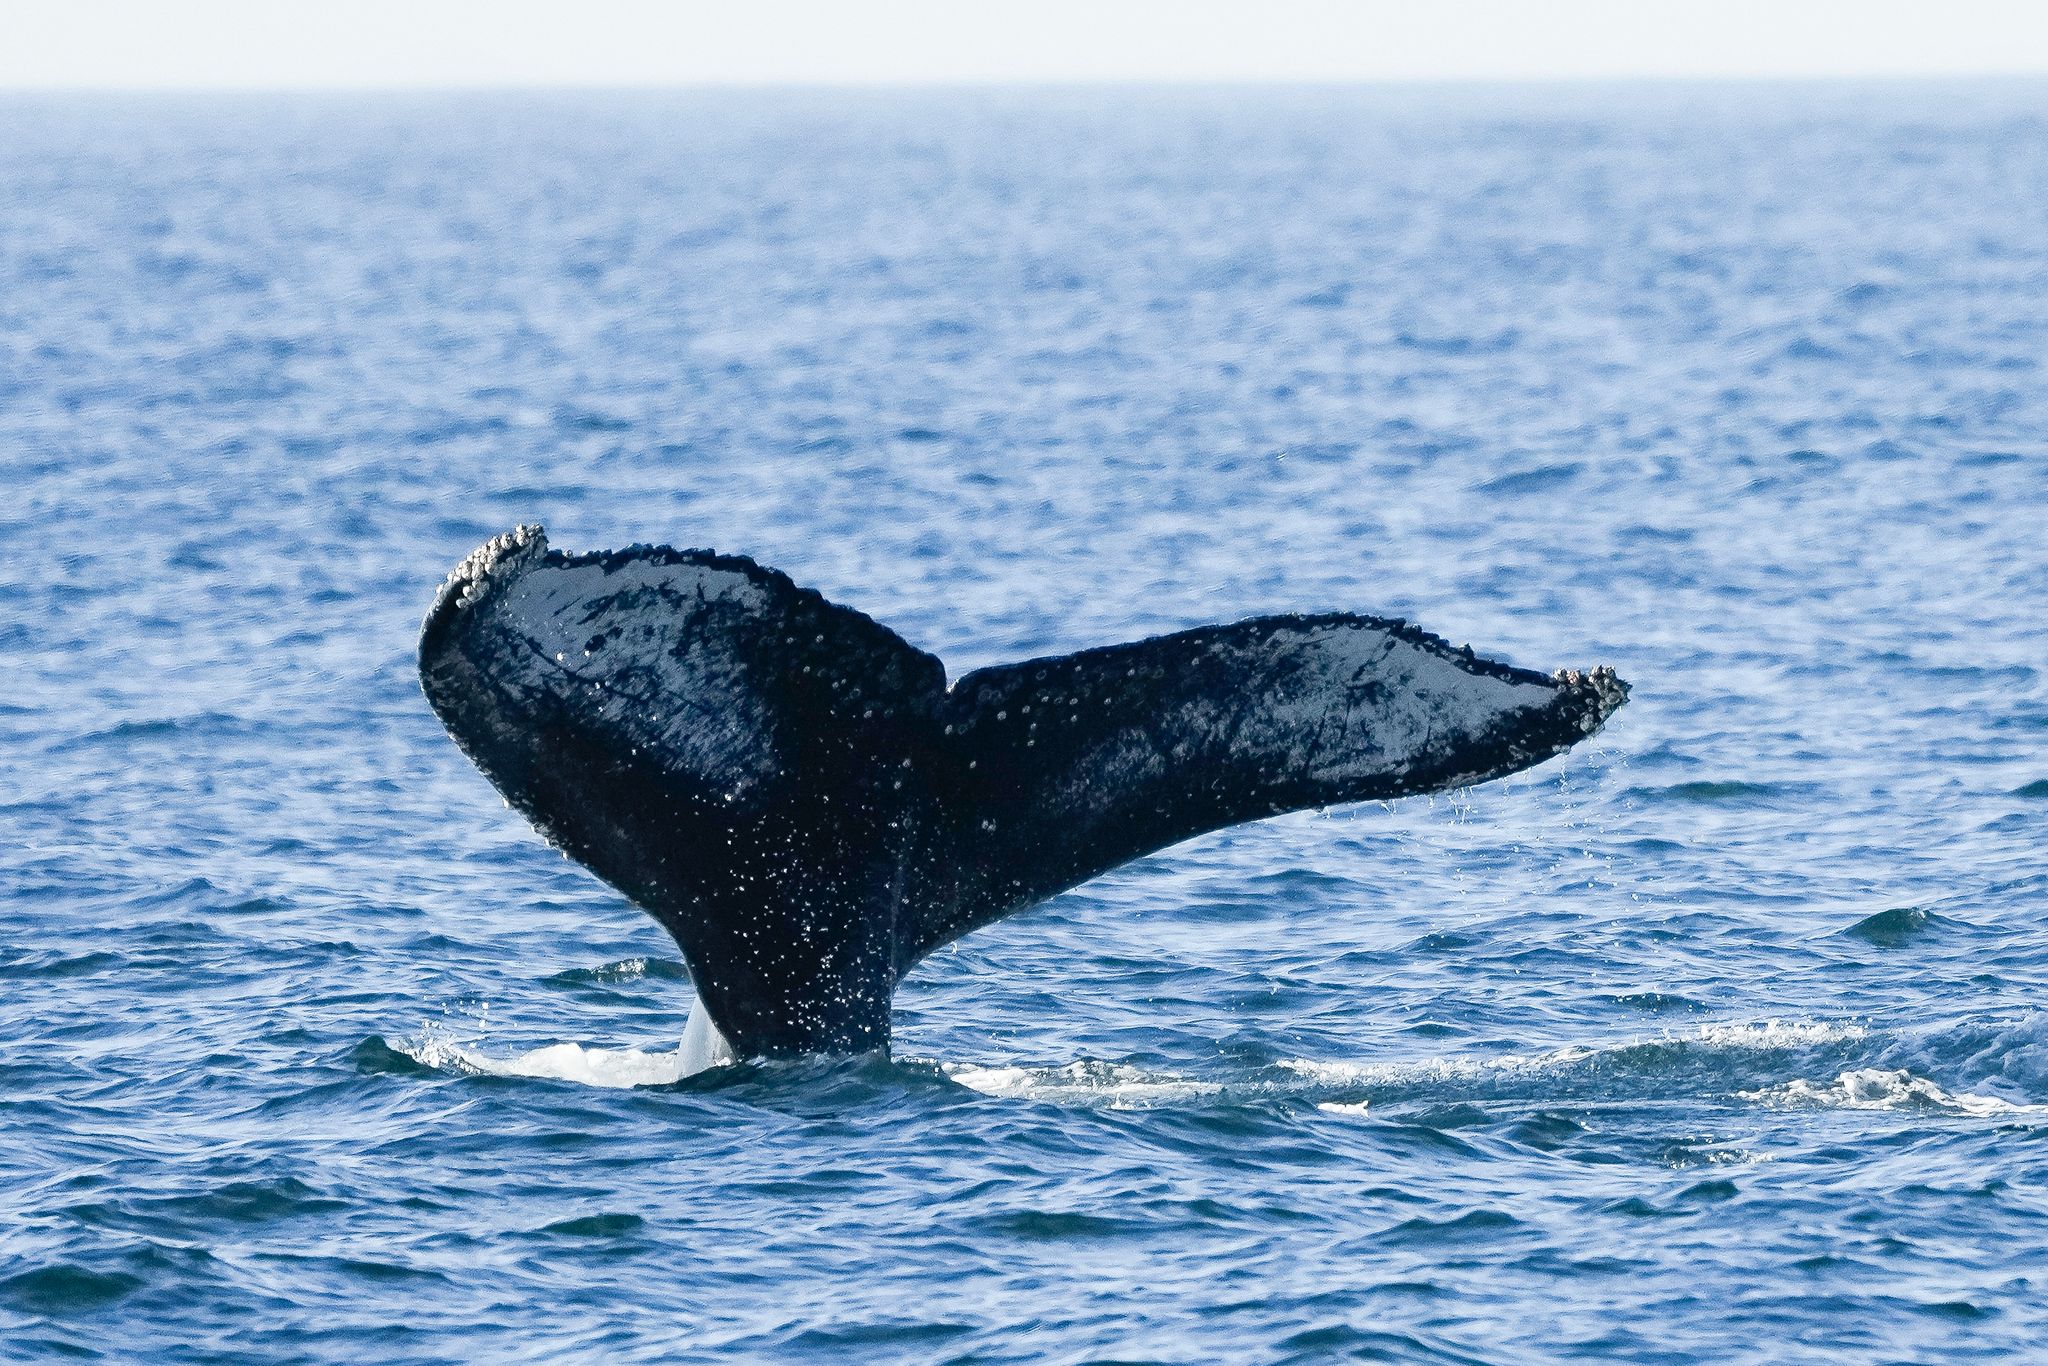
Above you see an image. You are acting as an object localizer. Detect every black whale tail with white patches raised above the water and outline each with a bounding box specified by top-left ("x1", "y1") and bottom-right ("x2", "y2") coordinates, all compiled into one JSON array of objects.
[{"x1": 420, "y1": 526, "x2": 1628, "y2": 1057}]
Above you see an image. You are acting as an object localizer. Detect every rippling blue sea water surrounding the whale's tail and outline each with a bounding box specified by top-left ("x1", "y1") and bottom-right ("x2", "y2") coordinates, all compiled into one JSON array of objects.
[{"x1": 0, "y1": 84, "x2": 2048, "y2": 1362}]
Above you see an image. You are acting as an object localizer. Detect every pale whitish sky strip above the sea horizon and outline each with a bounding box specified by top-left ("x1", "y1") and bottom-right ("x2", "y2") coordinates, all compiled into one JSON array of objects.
[{"x1": 0, "y1": 0, "x2": 2048, "y2": 90}]
